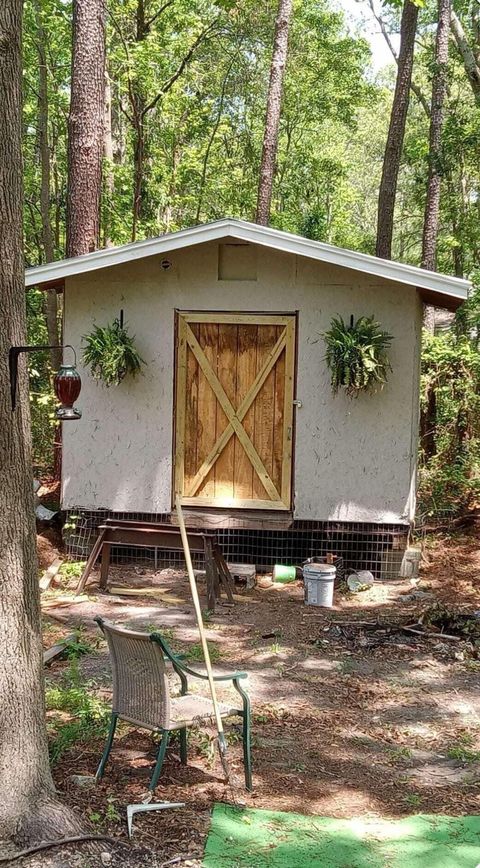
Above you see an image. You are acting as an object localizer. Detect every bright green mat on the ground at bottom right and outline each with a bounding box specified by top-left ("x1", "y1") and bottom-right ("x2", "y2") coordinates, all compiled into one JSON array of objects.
[{"x1": 203, "y1": 804, "x2": 480, "y2": 868}]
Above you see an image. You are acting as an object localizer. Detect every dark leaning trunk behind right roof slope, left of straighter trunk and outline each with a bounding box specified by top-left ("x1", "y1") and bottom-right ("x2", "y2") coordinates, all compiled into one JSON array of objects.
[{"x1": 376, "y1": 0, "x2": 418, "y2": 259}]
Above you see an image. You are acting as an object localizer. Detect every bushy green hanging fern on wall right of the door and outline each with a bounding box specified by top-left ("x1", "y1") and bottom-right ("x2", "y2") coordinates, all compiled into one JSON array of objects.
[{"x1": 324, "y1": 316, "x2": 393, "y2": 397}]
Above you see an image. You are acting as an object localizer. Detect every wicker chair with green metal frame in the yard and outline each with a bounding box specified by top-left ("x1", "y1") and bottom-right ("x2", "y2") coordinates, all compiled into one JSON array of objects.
[{"x1": 95, "y1": 617, "x2": 252, "y2": 791}]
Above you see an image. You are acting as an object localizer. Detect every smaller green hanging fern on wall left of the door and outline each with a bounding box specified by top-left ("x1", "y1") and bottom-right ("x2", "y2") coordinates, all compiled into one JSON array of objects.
[{"x1": 83, "y1": 319, "x2": 146, "y2": 386}]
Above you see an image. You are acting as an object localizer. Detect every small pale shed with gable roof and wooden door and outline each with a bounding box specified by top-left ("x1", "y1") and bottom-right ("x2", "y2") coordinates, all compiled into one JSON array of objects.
[{"x1": 26, "y1": 219, "x2": 469, "y2": 563}]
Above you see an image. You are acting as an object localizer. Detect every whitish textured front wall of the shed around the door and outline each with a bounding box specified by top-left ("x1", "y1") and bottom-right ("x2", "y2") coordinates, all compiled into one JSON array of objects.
[{"x1": 63, "y1": 243, "x2": 421, "y2": 522}]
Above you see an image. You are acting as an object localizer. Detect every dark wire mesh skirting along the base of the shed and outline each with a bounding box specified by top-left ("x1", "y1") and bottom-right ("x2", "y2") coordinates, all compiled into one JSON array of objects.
[{"x1": 64, "y1": 509, "x2": 409, "y2": 580}]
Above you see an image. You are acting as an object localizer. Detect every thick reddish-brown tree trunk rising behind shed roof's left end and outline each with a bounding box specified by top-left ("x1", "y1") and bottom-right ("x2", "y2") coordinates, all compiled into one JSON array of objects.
[{"x1": 67, "y1": 0, "x2": 105, "y2": 256}]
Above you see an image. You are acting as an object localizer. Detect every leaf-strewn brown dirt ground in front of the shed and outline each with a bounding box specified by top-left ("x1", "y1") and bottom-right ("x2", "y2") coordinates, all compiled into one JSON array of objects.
[{"x1": 31, "y1": 529, "x2": 480, "y2": 868}]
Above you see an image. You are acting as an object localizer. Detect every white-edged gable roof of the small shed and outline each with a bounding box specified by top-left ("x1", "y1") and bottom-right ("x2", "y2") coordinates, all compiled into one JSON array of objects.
[{"x1": 25, "y1": 217, "x2": 470, "y2": 309}]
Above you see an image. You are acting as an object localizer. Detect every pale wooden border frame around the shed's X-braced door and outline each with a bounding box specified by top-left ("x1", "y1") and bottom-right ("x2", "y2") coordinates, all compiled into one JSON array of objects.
[{"x1": 172, "y1": 308, "x2": 298, "y2": 513}]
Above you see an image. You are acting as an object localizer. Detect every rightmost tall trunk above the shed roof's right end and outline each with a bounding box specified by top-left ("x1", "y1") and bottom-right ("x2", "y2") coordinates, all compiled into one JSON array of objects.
[{"x1": 421, "y1": 0, "x2": 451, "y2": 271}]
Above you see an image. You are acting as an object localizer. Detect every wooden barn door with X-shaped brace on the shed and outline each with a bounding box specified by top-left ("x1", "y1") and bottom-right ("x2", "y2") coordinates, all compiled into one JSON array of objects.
[{"x1": 175, "y1": 312, "x2": 295, "y2": 510}]
